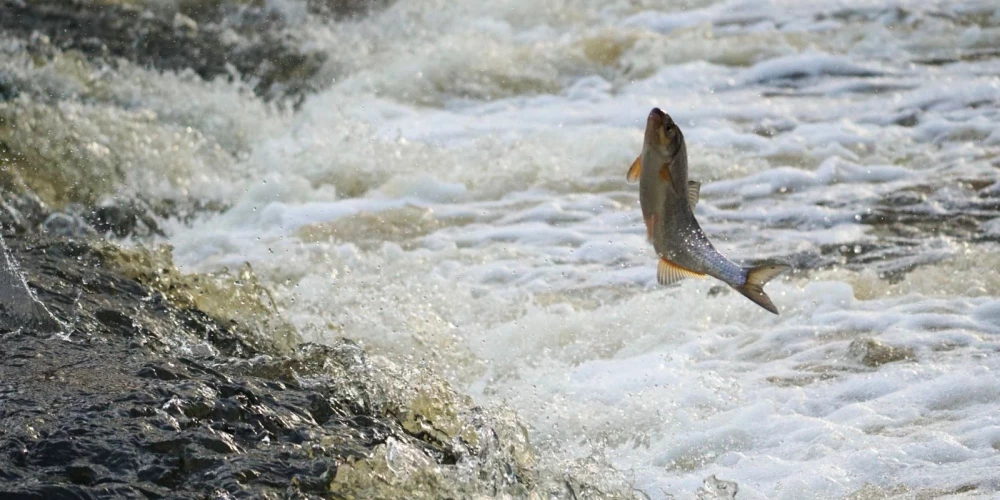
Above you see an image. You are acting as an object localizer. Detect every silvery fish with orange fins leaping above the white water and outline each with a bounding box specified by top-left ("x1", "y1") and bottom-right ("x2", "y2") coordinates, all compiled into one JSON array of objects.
[{"x1": 626, "y1": 108, "x2": 791, "y2": 314}]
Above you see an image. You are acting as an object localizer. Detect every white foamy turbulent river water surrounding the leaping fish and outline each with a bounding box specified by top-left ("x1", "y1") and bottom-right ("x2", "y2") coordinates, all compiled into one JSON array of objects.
[{"x1": 8, "y1": 0, "x2": 1000, "y2": 499}]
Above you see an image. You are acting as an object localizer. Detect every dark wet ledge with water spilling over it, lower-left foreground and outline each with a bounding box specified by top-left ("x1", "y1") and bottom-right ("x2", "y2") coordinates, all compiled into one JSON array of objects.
[{"x1": 0, "y1": 236, "x2": 631, "y2": 500}]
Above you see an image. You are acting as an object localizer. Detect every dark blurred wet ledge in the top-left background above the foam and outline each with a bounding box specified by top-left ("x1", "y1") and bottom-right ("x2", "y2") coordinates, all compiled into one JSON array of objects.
[{"x1": 0, "y1": 0, "x2": 326, "y2": 98}]
